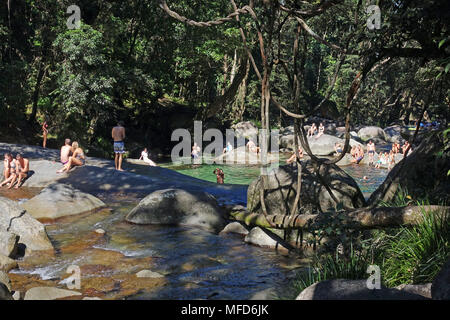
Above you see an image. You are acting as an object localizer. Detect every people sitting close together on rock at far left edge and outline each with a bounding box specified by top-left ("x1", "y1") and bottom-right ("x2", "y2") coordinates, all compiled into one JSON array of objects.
[{"x1": 0, "y1": 153, "x2": 30, "y2": 189}]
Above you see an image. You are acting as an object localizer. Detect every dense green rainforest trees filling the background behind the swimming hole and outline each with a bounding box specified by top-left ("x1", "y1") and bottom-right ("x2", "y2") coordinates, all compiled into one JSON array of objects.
[{"x1": 0, "y1": 0, "x2": 450, "y2": 154}]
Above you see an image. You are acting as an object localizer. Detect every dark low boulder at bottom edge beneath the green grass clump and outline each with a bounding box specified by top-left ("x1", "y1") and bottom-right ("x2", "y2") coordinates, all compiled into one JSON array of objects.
[{"x1": 296, "y1": 279, "x2": 427, "y2": 300}]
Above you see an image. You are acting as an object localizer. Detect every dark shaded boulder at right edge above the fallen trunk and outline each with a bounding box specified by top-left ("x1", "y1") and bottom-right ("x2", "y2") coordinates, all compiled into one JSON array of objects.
[{"x1": 369, "y1": 131, "x2": 450, "y2": 204}]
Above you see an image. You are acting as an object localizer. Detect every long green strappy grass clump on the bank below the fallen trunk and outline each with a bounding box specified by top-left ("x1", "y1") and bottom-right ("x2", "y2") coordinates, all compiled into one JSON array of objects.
[{"x1": 285, "y1": 204, "x2": 450, "y2": 298}]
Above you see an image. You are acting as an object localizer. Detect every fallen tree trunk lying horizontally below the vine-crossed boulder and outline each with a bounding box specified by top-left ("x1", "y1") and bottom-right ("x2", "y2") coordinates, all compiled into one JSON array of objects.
[{"x1": 230, "y1": 205, "x2": 450, "y2": 231}]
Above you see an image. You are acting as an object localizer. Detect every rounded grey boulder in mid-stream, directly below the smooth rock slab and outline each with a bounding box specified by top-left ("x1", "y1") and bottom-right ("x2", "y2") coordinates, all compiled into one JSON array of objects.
[{"x1": 126, "y1": 189, "x2": 226, "y2": 232}]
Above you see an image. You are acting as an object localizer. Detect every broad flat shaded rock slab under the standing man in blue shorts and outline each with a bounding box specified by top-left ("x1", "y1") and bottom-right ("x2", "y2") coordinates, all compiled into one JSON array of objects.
[{"x1": 0, "y1": 143, "x2": 247, "y2": 204}]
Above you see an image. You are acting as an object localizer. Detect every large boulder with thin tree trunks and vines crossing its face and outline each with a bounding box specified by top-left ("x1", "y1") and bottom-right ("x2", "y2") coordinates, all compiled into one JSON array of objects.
[{"x1": 247, "y1": 161, "x2": 365, "y2": 215}]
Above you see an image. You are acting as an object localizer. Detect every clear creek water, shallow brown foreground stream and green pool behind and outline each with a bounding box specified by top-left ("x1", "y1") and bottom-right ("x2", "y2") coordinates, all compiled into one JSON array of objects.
[{"x1": 0, "y1": 159, "x2": 387, "y2": 299}]
